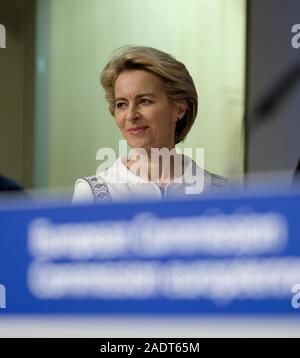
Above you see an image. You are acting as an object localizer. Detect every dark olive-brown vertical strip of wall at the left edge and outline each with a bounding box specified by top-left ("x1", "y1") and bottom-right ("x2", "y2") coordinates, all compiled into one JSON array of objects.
[{"x1": 0, "y1": 0, "x2": 35, "y2": 187}]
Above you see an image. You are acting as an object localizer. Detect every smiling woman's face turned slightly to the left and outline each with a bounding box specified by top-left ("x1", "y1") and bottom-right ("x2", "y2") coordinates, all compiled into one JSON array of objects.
[{"x1": 114, "y1": 70, "x2": 186, "y2": 150}]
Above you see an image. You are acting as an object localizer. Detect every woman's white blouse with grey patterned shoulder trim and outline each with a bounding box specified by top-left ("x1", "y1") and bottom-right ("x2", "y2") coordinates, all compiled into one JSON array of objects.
[{"x1": 72, "y1": 155, "x2": 227, "y2": 203}]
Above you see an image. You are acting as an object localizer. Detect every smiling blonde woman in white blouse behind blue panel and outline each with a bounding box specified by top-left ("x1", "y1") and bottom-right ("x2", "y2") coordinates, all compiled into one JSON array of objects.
[{"x1": 73, "y1": 46, "x2": 226, "y2": 202}]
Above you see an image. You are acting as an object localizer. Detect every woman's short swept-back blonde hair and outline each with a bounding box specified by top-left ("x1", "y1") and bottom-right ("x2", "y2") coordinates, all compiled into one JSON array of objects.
[{"x1": 100, "y1": 46, "x2": 198, "y2": 144}]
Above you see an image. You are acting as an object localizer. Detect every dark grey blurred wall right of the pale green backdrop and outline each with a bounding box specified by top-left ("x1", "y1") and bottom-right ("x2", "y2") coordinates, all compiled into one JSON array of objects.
[{"x1": 245, "y1": 0, "x2": 300, "y2": 188}]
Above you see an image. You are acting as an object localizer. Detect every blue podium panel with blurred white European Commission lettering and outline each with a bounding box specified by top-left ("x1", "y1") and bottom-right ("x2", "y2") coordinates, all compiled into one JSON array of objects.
[{"x1": 0, "y1": 193, "x2": 300, "y2": 316}]
